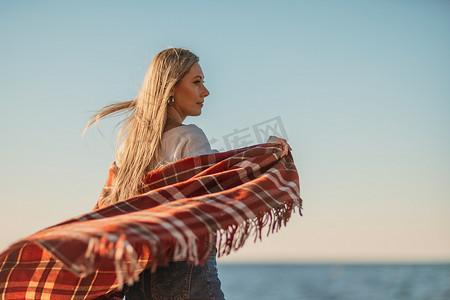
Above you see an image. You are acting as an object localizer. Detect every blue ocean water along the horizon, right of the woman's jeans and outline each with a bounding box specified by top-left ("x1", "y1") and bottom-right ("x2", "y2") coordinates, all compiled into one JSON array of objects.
[{"x1": 219, "y1": 264, "x2": 450, "y2": 300}]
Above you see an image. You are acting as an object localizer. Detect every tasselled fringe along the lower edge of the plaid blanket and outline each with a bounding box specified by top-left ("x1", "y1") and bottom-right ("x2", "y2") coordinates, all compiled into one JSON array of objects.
[{"x1": 85, "y1": 199, "x2": 302, "y2": 291}]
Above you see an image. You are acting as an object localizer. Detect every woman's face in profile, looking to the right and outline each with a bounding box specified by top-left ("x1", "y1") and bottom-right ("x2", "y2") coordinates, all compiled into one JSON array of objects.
[{"x1": 171, "y1": 63, "x2": 209, "y2": 120}]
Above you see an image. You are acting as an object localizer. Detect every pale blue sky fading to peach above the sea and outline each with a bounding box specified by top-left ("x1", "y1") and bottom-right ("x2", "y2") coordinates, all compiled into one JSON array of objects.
[{"x1": 0, "y1": 0, "x2": 450, "y2": 263}]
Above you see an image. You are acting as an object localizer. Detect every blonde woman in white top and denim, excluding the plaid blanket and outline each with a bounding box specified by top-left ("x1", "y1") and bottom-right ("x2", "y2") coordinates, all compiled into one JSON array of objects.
[{"x1": 86, "y1": 48, "x2": 290, "y2": 300}]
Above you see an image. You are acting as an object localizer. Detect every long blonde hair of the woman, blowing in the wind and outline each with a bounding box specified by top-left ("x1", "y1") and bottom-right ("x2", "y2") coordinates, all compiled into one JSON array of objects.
[{"x1": 83, "y1": 48, "x2": 199, "y2": 204}]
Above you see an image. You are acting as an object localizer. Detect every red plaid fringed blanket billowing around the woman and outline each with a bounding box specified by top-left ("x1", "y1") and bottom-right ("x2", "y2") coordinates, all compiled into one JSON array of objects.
[{"x1": 0, "y1": 144, "x2": 302, "y2": 299}]
